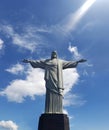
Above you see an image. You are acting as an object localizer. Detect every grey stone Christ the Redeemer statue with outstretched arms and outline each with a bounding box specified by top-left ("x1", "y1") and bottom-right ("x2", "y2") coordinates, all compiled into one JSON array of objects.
[{"x1": 23, "y1": 51, "x2": 86, "y2": 113}]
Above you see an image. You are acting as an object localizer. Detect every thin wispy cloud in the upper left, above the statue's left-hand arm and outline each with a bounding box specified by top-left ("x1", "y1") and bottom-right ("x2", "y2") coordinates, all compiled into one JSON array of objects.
[{"x1": 0, "y1": 24, "x2": 49, "y2": 52}]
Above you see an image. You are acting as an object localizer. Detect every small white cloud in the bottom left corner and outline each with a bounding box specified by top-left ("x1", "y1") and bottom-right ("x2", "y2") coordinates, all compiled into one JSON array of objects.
[{"x1": 0, "y1": 120, "x2": 18, "y2": 130}]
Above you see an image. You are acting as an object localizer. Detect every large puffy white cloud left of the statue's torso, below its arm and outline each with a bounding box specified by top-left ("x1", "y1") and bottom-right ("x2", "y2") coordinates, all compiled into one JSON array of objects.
[{"x1": 0, "y1": 67, "x2": 45, "y2": 103}]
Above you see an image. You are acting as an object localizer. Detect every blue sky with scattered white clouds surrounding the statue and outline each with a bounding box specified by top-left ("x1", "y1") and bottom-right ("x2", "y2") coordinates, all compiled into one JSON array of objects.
[{"x1": 0, "y1": 0, "x2": 109, "y2": 130}]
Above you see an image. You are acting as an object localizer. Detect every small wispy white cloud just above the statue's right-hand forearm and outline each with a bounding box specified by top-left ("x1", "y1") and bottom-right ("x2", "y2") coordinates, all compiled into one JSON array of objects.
[{"x1": 68, "y1": 45, "x2": 82, "y2": 59}]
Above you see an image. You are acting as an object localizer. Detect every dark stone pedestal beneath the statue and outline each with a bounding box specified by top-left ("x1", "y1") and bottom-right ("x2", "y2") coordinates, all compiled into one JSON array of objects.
[{"x1": 38, "y1": 114, "x2": 70, "y2": 130}]
